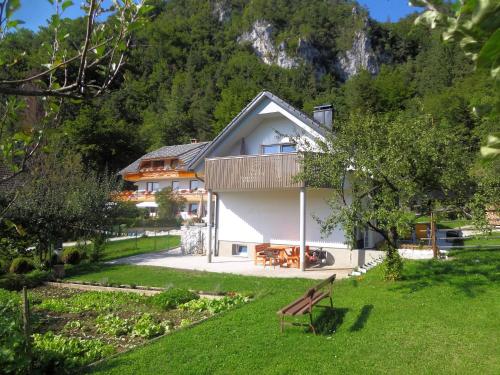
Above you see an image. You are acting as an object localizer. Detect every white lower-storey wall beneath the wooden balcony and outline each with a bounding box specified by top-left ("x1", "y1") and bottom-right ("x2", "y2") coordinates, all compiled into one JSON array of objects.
[{"x1": 218, "y1": 189, "x2": 347, "y2": 248}]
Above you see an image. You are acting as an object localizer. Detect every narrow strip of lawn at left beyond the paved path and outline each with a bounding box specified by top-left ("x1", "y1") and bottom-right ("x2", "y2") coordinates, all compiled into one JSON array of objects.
[{"x1": 73, "y1": 236, "x2": 180, "y2": 261}]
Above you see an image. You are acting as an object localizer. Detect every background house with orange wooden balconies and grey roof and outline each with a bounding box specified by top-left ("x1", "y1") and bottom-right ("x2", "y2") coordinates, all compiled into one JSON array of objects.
[{"x1": 118, "y1": 140, "x2": 208, "y2": 219}]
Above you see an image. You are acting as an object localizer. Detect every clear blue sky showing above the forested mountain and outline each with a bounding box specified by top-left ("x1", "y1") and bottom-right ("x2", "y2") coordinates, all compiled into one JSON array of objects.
[{"x1": 14, "y1": 0, "x2": 422, "y2": 31}]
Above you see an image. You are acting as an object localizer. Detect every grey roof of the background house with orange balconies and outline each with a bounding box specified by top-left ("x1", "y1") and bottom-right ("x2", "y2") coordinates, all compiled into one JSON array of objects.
[{"x1": 119, "y1": 142, "x2": 210, "y2": 175}]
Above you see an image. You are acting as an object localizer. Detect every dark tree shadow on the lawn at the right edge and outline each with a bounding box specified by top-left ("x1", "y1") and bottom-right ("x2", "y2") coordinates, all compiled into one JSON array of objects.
[{"x1": 392, "y1": 249, "x2": 500, "y2": 298}]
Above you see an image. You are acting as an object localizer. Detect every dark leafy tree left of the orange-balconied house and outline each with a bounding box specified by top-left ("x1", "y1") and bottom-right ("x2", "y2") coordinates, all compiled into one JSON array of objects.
[{"x1": 6, "y1": 152, "x2": 118, "y2": 261}]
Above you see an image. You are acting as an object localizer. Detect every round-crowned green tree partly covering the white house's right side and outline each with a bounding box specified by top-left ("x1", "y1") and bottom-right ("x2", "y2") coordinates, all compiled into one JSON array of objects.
[{"x1": 299, "y1": 114, "x2": 470, "y2": 280}]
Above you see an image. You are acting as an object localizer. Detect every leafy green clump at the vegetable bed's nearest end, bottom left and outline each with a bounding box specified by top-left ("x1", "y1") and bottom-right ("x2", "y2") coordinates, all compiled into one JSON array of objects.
[{"x1": 33, "y1": 332, "x2": 114, "y2": 373}]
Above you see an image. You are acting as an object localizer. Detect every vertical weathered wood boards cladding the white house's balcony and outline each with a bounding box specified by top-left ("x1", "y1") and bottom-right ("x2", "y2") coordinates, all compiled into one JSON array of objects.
[{"x1": 205, "y1": 153, "x2": 303, "y2": 191}]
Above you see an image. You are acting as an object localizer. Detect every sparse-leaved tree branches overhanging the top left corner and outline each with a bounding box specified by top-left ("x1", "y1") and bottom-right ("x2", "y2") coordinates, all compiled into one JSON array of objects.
[{"x1": 0, "y1": 0, "x2": 151, "y2": 198}]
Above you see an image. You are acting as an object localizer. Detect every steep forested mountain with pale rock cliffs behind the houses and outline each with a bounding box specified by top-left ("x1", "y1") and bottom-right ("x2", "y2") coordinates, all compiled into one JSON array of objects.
[{"x1": 7, "y1": 0, "x2": 486, "y2": 170}]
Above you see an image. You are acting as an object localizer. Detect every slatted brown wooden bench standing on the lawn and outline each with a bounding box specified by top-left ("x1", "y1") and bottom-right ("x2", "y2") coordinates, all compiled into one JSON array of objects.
[{"x1": 277, "y1": 274, "x2": 337, "y2": 334}]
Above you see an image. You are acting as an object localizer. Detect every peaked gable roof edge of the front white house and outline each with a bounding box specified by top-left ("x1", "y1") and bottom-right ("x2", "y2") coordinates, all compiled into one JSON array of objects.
[{"x1": 188, "y1": 91, "x2": 328, "y2": 169}]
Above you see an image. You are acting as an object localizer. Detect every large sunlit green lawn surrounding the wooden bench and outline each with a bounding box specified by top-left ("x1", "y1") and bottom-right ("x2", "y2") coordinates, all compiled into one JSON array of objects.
[{"x1": 65, "y1": 244, "x2": 500, "y2": 375}]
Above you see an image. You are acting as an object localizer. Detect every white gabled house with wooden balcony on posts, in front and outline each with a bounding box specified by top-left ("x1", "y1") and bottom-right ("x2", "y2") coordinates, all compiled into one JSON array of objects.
[{"x1": 187, "y1": 92, "x2": 378, "y2": 268}]
